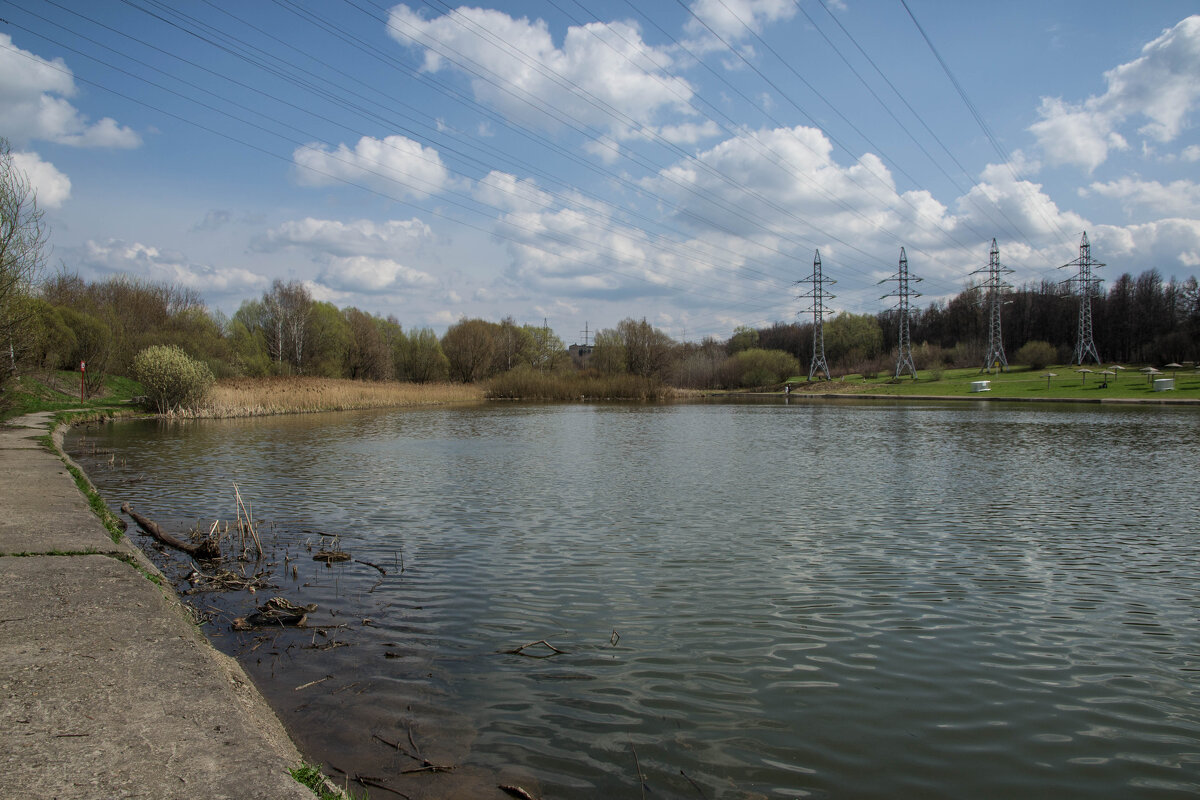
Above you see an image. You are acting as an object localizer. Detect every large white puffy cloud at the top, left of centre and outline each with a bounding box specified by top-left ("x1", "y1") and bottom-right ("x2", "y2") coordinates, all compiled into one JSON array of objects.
[{"x1": 388, "y1": 5, "x2": 692, "y2": 139}]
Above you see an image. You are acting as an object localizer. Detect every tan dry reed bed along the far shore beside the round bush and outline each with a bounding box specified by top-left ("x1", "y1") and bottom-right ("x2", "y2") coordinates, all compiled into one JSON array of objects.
[{"x1": 175, "y1": 377, "x2": 484, "y2": 419}]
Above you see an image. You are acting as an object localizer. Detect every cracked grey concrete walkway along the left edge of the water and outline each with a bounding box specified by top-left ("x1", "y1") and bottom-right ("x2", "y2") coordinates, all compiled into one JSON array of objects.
[{"x1": 0, "y1": 415, "x2": 313, "y2": 800}]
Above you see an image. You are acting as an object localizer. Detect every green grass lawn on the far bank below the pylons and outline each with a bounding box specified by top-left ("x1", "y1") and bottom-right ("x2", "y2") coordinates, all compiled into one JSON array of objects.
[{"x1": 788, "y1": 365, "x2": 1200, "y2": 402}]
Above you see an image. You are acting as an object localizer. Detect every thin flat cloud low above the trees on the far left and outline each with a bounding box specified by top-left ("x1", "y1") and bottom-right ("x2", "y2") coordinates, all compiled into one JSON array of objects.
[{"x1": 73, "y1": 239, "x2": 268, "y2": 293}]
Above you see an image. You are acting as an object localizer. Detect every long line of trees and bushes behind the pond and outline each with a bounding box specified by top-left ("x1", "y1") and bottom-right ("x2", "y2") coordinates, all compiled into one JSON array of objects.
[{"x1": 6, "y1": 262, "x2": 1200, "y2": 398}]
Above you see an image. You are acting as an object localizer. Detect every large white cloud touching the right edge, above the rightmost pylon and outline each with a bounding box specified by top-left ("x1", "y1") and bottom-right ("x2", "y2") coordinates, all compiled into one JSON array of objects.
[{"x1": 1030, "y1": 16, "x2": 1200, "y2": 172}]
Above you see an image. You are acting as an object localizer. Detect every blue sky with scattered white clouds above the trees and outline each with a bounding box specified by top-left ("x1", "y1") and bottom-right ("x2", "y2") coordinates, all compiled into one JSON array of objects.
[{"x1": 0, "y1": 0, "x2": 1200, "y2": 343}]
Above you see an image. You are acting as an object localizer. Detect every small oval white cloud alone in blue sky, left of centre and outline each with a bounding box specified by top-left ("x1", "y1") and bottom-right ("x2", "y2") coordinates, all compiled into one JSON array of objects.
[{"x1": 292, "y1": 136, "x2": 450, "y2": 198}]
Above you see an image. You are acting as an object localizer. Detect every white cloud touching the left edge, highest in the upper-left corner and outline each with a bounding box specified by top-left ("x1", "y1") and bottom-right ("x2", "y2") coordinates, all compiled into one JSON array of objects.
[{"x1": 0, "y1": 34, "x2": 142, "y2": 148}]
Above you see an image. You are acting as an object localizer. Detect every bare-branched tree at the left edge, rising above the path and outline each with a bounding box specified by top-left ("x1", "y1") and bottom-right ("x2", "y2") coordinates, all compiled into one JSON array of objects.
[{"x1": 0, "y1": 138, "x2": 49, "y2": 373}]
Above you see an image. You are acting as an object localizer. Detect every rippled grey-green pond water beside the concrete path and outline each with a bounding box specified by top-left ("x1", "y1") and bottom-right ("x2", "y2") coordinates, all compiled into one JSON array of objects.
[{"x1": 68, "y1": 403, "x2": 1200, "y2": 800}]
